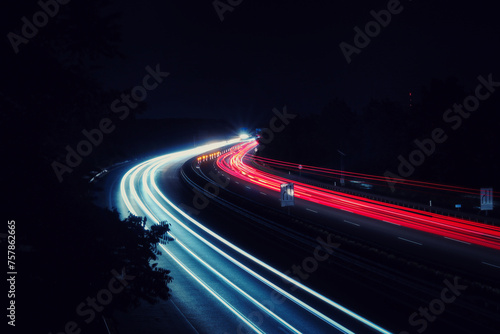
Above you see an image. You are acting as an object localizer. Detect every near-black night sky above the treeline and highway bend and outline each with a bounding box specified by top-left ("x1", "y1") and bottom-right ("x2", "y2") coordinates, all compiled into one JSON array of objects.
[{"x1": 91, "y1": 0, "x2": 500, "y2": 124}]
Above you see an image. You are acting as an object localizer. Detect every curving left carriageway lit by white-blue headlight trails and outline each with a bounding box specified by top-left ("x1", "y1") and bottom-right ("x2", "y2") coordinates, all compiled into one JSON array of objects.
[{"x1": 116, "y1": 140, "x2": 389, "y2": 333}]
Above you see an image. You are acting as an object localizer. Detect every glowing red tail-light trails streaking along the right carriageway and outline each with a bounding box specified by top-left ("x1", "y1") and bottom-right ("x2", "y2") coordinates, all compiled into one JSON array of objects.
[{"x1": 217, "y1": 141, "x2": 500, "y2": 249}]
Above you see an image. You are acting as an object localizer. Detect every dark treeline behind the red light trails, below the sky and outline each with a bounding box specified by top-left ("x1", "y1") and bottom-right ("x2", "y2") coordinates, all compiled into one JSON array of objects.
[{"x1": 260, "y1": 74, "x2": 500, "y2": 189}]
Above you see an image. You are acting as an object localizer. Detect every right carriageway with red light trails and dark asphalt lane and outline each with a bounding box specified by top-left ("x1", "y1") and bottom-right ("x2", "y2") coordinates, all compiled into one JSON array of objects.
[{"x1": 217, "y1": 142, "x2": 500, "y2": 282}]
